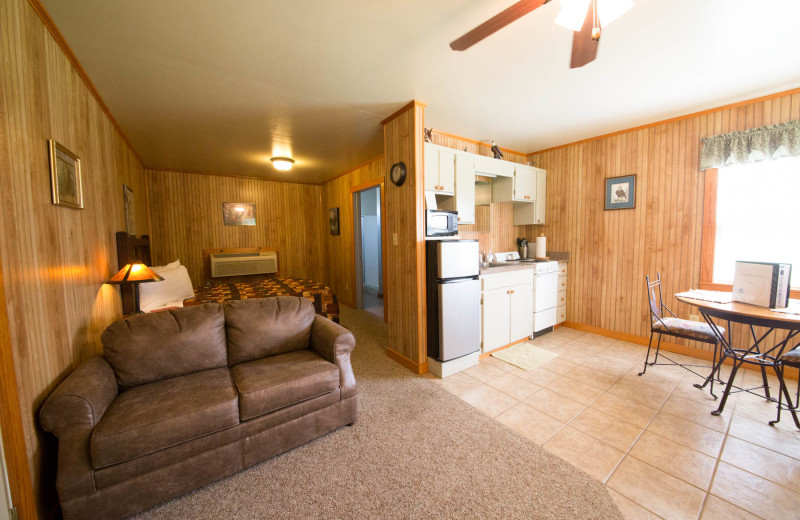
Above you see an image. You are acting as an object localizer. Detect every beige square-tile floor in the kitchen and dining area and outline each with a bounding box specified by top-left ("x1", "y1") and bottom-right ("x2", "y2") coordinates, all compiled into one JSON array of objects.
[{"x1": 434, "y1": 327, "x2": 800, "y2": 519}]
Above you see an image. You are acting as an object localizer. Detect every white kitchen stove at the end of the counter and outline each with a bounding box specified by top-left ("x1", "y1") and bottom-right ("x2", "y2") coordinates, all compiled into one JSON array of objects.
[{"x1": 495, "y1": 251, "x2": 558, "y2": 337}]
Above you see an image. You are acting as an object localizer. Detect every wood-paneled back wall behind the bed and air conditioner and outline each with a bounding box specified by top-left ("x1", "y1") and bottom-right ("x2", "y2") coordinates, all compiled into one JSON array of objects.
[{"x1": 147, "y1": 170, "x2": 327, "y2": 287}]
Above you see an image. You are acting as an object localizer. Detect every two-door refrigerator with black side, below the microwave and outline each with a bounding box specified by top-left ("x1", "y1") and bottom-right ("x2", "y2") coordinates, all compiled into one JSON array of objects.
[{"x1": 425, "y1": 240, "x2": 481, "y2": 377}]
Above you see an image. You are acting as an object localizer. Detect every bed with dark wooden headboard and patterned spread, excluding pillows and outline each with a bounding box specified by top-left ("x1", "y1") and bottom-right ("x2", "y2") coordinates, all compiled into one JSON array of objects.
[{"x1": 117, "y1": 231, "x2": 339, "y2": 323}]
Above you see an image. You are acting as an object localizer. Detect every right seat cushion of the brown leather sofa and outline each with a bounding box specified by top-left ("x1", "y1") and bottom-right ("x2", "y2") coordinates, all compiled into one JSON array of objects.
[{"x1": 231, "y1": 349, "x2": 339, "y2": 421}]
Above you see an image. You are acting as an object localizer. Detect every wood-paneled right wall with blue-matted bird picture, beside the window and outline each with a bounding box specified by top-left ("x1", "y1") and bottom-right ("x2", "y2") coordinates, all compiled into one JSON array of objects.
[{"x1": 528, "y1": 93, "x2": 800, "y2": 356}]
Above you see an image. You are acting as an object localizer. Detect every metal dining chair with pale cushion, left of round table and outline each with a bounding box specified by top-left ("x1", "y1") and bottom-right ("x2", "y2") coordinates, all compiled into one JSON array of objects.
[{"x1": 639, "y1": 273, "x2": 725, "y2": 399}]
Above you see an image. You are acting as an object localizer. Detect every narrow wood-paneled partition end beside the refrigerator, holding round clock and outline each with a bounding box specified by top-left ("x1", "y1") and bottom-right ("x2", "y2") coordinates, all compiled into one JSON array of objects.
[{"x1": 383, "y1": 101, "x2": 428, "y2": 373}]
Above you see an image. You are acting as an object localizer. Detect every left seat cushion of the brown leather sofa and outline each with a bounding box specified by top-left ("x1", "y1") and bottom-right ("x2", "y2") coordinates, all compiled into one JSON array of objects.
[{"x1": 90, "y1": 368, "x2": 239, "y2": 468}]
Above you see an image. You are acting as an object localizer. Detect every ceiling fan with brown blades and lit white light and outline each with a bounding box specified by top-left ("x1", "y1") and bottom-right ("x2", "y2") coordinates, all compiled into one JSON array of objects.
[{"x1": 450, "y1": 0, "x2": 633, "y2": 69}]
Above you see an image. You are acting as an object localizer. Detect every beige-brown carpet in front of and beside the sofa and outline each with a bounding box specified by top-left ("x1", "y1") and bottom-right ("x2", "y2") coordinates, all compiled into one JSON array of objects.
[{"x1": 131, "y1": 306, "x2": 622, "y2": 520}]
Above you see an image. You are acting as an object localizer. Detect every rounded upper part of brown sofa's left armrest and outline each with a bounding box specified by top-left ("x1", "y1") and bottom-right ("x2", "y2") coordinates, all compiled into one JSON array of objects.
[{"x1": 39, "y1": 355, "x2": 118, "y2": 439}]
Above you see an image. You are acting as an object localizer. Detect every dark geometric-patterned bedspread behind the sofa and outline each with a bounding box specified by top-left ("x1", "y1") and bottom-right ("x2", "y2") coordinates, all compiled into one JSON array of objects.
[{"x1": 183, "y1": 278, "x2": 339, "y2": 323}]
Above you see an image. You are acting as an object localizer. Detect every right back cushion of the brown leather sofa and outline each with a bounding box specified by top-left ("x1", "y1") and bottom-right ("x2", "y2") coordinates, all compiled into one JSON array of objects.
[{"x1": 224, "y1": 296, "x2": 314, "y2": 366}]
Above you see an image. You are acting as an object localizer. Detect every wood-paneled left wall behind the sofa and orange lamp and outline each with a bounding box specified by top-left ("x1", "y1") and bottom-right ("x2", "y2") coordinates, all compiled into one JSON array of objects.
[{"x1": 0, "y1": 0, "x2": 150, "y2": 518}]
